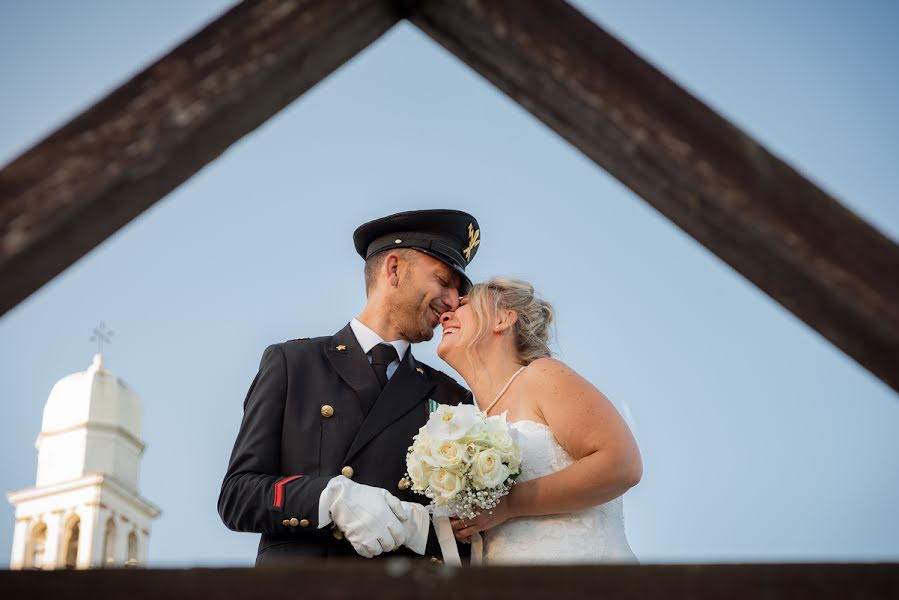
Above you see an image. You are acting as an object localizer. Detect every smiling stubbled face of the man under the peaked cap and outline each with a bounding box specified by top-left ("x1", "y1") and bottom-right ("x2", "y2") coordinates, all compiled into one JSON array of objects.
[{"x1": 391, "y1": 252, "x2": 459, "y2": 344}]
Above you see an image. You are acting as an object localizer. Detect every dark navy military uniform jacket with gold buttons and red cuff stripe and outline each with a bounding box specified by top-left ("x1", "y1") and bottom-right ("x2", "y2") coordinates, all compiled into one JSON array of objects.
[{"x1": 218, "y1": 325, "x2": 472, "y2": 565}]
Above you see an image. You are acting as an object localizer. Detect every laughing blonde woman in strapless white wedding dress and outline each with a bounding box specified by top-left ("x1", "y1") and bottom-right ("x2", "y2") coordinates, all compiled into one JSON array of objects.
[{"x1": 437, "y1": 279, "x2": 643, "y2": 564}]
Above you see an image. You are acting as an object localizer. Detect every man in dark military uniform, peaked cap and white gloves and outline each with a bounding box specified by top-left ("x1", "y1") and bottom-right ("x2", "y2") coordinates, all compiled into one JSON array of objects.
[{"x1": 218, "y1": 210, "x2": 480, "y2": 566}]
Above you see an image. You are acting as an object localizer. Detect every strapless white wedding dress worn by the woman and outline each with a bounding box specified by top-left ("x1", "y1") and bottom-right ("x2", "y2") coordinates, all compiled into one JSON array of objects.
[{"x1": 482, "y1": 421, "x2": 637, "y2": 565}]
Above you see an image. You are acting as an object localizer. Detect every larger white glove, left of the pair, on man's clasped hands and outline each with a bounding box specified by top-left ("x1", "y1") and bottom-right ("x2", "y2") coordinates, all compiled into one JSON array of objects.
[{"x1": 318, "y1": 475, "x2": 408, "y2": 558}]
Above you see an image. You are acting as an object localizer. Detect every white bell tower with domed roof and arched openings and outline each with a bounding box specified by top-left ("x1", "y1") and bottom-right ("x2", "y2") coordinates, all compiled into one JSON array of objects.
[{"x1": 7, "y1": 354, "x2": 159, "y2": 569}]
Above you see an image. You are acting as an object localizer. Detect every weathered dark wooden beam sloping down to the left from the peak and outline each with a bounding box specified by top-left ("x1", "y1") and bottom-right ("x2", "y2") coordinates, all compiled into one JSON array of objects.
[{"x1": 0, "y1": 0, "x2": 400, "y2": 314}]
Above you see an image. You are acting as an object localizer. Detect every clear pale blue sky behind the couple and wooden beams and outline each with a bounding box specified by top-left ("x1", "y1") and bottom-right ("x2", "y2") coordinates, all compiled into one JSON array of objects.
[{"x1": 0, "y1": 0, "x2": 899, "y2": 566}]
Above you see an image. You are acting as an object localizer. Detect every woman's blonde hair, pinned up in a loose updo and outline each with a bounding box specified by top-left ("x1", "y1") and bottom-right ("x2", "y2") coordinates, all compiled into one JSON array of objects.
[{"x1": 468, "y1": 277, "x2": 555, "y2": 365}]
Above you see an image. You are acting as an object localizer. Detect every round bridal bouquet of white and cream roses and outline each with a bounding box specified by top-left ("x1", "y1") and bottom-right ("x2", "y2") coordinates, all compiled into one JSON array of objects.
[{"x1": 406, "y1": 404, "x2": 521, "y2": 519}]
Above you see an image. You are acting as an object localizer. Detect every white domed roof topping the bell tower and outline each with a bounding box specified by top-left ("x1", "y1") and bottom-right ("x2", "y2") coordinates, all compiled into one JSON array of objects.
[{"x1": 41, "y1": 354, "x2": 144, "y2": 442}]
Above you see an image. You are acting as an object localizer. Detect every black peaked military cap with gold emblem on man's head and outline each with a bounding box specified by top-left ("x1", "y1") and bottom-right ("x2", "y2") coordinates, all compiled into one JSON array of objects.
[{"x1": 353, "y1": 209, "x2": 481, "y2": 294}]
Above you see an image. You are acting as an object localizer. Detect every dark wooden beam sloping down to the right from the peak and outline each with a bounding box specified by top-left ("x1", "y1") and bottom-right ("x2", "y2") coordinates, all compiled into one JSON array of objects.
[{"x1": 409, "y1": 0, "x2": 899, "y2": 390}]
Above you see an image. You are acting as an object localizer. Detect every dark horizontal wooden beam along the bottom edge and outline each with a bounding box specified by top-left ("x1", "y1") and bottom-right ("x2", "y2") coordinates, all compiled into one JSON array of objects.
[{"x1": 0, "y1": 559, "x2": 899, "y2": 600}]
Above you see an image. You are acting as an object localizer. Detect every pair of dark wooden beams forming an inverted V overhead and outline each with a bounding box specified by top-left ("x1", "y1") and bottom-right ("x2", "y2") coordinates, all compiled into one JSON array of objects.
[{"x1": 0, "y1": 0, "x2": 899, "y2": 390}]
